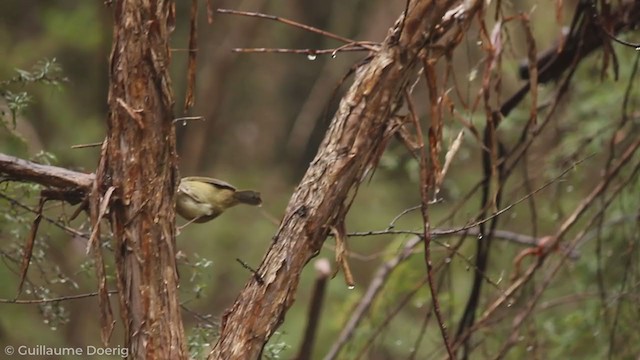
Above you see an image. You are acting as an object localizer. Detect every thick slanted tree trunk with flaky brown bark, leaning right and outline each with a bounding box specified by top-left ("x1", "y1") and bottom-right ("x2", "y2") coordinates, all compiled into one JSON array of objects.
[{"x1": 209, "y1": 0, "x2": 464, "y2": 360}]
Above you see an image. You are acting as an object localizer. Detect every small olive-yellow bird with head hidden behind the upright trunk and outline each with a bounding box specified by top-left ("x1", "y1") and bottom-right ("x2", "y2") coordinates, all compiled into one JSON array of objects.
[{"x1": 176, "y1": 176, "x2": 262, "y2": 226}]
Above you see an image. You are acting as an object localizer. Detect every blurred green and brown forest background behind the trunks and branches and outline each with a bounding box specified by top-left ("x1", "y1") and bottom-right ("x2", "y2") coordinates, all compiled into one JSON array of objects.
[{"x1": 0, "y1": 0, "x2": 640, "y2": 359}]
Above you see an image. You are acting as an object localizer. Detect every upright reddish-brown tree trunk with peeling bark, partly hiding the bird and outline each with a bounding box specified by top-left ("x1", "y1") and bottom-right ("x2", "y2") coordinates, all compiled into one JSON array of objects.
[{"x1": 92, "y1": 0, "x2": 187, "y2": 359}]
